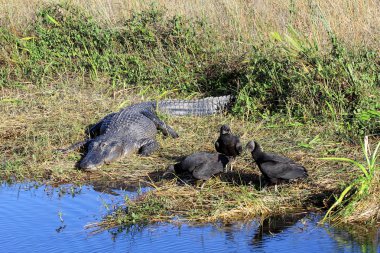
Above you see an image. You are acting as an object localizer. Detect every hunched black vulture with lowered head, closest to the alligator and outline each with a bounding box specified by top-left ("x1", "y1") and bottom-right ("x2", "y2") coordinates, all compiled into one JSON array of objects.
[{"x1": 165, "y1": 152, "x2": 229, "y2": 180}]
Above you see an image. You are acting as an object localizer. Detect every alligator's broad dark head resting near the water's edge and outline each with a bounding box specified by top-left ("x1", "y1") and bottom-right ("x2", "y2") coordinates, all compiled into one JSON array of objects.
[{"x1": 79, "y1": 139, "x2": 124, "y2": 170}]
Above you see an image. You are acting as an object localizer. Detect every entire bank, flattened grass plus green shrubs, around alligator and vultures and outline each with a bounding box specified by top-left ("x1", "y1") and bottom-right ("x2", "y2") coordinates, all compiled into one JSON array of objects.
[{"x1": 0, "y1": 1, "x2": 380, "y2": 225}]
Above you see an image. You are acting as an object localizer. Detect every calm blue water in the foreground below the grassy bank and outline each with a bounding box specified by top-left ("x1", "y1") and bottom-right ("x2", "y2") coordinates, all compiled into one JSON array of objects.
[{"x1": 0, "y1": 184, "x2": 380, "y2": 253}]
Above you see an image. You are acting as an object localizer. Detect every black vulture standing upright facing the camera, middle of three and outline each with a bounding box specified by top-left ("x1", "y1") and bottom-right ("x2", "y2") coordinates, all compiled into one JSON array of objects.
[{"x1": 215, "y1": 125, "x2": 243, "y2": 158}]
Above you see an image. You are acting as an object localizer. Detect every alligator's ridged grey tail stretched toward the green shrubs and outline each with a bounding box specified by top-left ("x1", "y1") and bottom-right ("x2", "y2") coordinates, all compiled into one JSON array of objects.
[{"x1": 157, "y1": 95, "x2": 234, "y2": 116}]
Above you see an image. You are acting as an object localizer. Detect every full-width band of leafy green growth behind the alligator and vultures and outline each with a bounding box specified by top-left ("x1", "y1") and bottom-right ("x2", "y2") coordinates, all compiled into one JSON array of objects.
[{"x1": 0, "y1": 3, "x2": 380, "y2": 137}]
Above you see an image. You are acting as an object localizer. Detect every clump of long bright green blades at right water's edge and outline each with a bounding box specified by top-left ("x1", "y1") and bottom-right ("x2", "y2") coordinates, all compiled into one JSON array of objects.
[{"x1": 321, "y1": 136, "x2": 380, "y2": 222}]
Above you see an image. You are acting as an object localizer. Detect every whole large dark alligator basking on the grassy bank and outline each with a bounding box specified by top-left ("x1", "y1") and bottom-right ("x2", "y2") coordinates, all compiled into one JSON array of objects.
[{"x1": 60, "y1": 95, "x2": 233, "y2": 170}]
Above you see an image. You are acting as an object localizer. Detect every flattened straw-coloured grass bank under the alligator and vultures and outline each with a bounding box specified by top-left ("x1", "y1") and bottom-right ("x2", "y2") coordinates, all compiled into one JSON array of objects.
[{"x1": 0, "y1": 81, "x2": 378, "y2": 225}]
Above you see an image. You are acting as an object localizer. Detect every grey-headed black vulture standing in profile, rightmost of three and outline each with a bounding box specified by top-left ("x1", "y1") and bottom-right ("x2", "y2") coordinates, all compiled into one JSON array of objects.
[{"x1": 247, "y1": 141, "x2": 308, "y2": 187}]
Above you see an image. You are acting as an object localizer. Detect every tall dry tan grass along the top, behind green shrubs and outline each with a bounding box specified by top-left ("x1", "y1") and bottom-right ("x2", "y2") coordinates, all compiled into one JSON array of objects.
[{"x1": 0, "y1": 0, "x2": 380, "y2": 50}]
